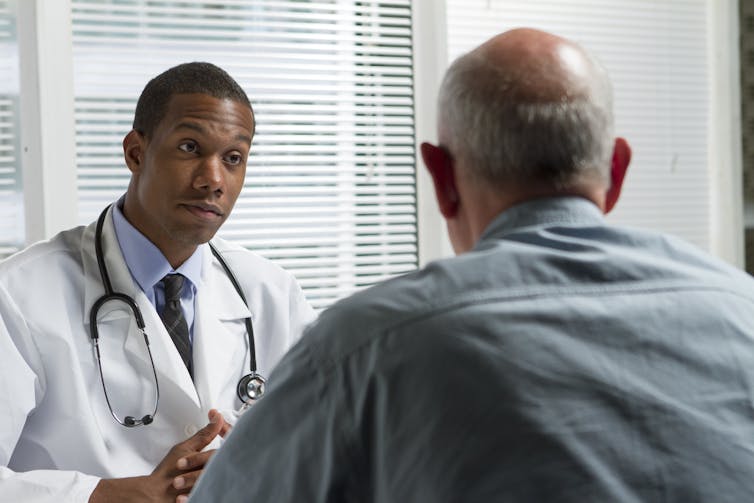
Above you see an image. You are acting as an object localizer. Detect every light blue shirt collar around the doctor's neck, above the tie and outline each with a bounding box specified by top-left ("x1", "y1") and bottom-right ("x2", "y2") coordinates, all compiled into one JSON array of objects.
[{"x1": 113, "y1": 197, "x2": 205, "y2": 304}]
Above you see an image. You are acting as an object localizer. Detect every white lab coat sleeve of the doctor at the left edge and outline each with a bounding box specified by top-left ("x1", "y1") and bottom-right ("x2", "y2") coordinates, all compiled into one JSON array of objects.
[{"x1": 0, "y1": 288, "x2": 100, "y2": 503}]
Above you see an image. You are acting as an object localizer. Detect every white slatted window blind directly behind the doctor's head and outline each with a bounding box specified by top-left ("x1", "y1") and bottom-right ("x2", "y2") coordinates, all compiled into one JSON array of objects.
[{"x1": 72, "y1": 0, "x2": 417, "y2": 308}]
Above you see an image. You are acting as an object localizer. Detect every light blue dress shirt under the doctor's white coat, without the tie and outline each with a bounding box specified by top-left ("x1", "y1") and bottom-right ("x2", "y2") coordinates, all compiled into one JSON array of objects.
[{"x1": 108, "y1": 197, "x2": 204, "y2": 342}]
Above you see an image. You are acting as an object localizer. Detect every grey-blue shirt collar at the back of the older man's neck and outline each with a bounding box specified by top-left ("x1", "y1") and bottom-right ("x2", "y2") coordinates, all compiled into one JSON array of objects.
[{"x1": 476, "y1": 196, "x2": 605, "y2": 248}]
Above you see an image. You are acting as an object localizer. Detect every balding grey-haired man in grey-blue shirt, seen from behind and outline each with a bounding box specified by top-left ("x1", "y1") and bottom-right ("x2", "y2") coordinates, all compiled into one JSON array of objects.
[{"x1": 191, "y1": 29, "x2": 754, "y2": 503}]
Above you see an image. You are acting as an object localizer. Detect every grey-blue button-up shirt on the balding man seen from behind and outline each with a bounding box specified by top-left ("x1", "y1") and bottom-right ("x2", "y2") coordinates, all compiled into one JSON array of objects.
[{"x1": 191, "y1": 198, "x2": 754, "y2": 503}]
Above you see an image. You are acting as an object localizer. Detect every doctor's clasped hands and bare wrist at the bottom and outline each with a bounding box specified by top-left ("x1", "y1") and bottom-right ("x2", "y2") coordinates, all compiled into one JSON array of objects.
[{"x1": 89, "y1": 411, "x2": 229, "y2": 503}]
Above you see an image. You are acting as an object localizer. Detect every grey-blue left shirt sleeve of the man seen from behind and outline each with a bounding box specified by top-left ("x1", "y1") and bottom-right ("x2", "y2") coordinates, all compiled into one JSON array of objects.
[{"x1": 190, "y1": 337, "x2": 348, "y2": 503}]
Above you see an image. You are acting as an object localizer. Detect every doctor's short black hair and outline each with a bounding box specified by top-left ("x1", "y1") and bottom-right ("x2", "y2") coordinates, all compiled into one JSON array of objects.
[{"x1": 133, "y1": 62, "x2": 256, "y2": 138}]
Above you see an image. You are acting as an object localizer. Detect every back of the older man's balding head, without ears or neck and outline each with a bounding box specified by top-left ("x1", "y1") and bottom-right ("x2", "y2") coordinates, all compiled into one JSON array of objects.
[{"x1": 439, "y1": 28, "x2": 613, "y2": 191}]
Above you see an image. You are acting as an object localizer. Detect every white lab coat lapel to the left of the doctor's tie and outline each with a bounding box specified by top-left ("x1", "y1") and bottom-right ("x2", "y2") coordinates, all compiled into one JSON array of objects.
[{"x1": 82, "y1": 209, "x2": 199, "y2": 407}]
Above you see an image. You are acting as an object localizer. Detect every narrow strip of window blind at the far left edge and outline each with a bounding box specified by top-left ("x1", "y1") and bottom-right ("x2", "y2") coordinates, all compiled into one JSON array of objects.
[{"x1": 0, "y1": 0, "x2": 25, "y2": 257}]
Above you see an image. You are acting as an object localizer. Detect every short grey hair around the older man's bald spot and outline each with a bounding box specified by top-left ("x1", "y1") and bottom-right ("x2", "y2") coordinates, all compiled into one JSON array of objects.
[{"x1": 438, "y1": 51, "x2": 613, "y2": 190}]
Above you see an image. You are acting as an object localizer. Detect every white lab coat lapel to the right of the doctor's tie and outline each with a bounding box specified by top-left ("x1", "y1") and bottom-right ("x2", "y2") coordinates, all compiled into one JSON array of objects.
[{"x1": 194, "y1": 245, "x2": 250, "y2": 407}]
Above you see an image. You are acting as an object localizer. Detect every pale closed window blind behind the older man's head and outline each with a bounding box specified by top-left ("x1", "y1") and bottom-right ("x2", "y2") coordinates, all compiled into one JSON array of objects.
[{"x1": 447, "y1": 0, "x2": 711, "y2": 249}]
